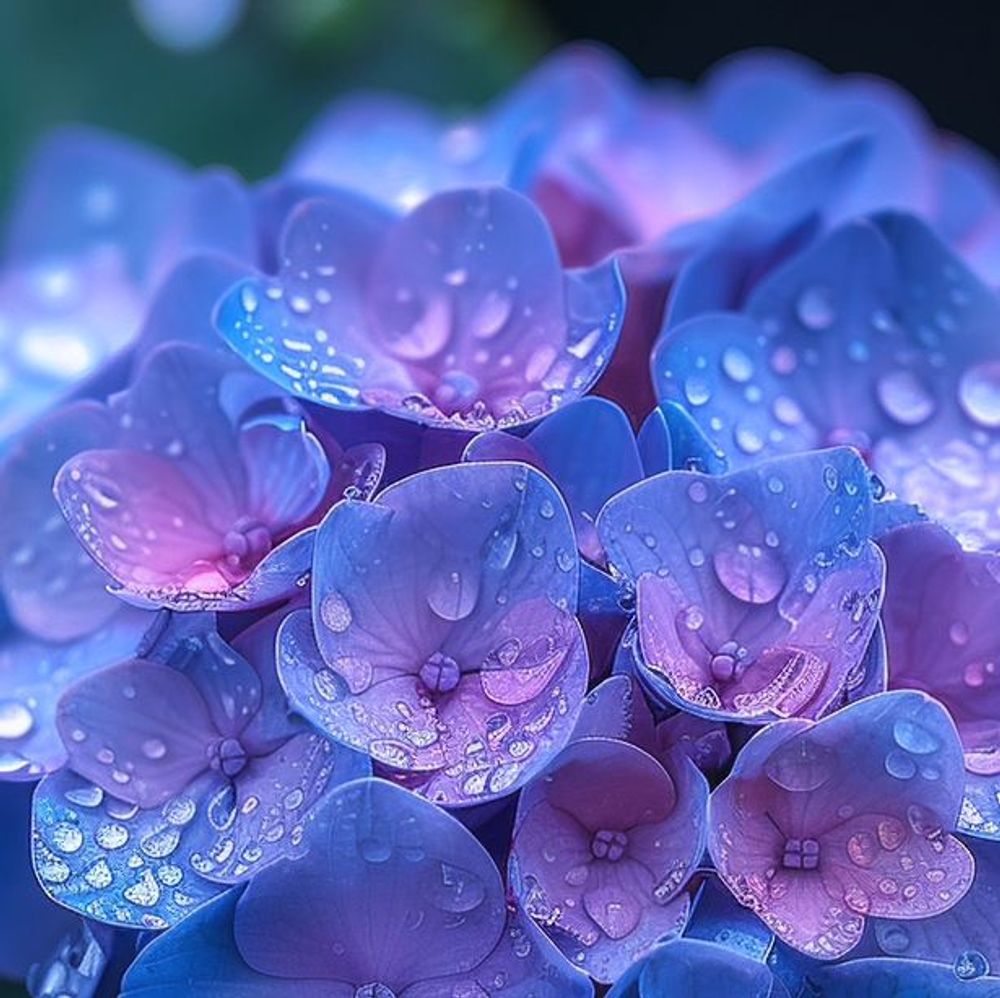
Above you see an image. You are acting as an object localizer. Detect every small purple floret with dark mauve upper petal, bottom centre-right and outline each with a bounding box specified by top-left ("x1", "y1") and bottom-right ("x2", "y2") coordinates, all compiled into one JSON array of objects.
[{"x1": 510, "y1": 737, "x2": 708, "y2": 982}]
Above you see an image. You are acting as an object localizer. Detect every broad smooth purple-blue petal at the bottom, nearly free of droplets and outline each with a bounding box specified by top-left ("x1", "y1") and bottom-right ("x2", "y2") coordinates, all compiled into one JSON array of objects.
[{"x1": 235, "y1": 780, "x2": 506, "y2": 994}]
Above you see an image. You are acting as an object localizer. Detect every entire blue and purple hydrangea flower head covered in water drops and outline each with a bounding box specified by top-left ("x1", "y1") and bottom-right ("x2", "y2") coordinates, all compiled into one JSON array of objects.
[{"x1": 0, "y1": 41, "x2": 1000, "y2": 998}]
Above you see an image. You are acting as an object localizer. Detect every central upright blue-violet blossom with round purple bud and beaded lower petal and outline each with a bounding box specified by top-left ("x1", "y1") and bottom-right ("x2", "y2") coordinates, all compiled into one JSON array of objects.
[{"x1": 279, "y1": 463, "x2": 587, "y2": 805}]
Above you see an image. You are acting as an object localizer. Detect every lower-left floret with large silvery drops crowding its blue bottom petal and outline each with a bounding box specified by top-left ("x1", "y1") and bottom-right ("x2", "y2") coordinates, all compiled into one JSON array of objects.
[{"x1": 34, "y1": 617, "x2": 368, "y2": 928}]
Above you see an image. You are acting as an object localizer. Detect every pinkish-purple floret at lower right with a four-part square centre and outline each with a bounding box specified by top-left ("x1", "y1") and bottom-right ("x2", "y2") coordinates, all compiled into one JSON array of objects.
[{"x1": 708, "y1": 692, "x2": 974, "y2": 960}]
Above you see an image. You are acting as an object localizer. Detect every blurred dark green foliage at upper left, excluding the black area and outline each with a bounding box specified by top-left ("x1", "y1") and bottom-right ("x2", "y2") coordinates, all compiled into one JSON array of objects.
[{"x1": 0, "y1": 0, "x2": 551, "y2": 998}]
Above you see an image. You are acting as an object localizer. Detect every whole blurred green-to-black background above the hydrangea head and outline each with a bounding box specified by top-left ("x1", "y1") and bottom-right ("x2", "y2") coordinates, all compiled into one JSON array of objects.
[{"x1": 0, "y1": 0, "x2": 1000, "y2": 998}]
